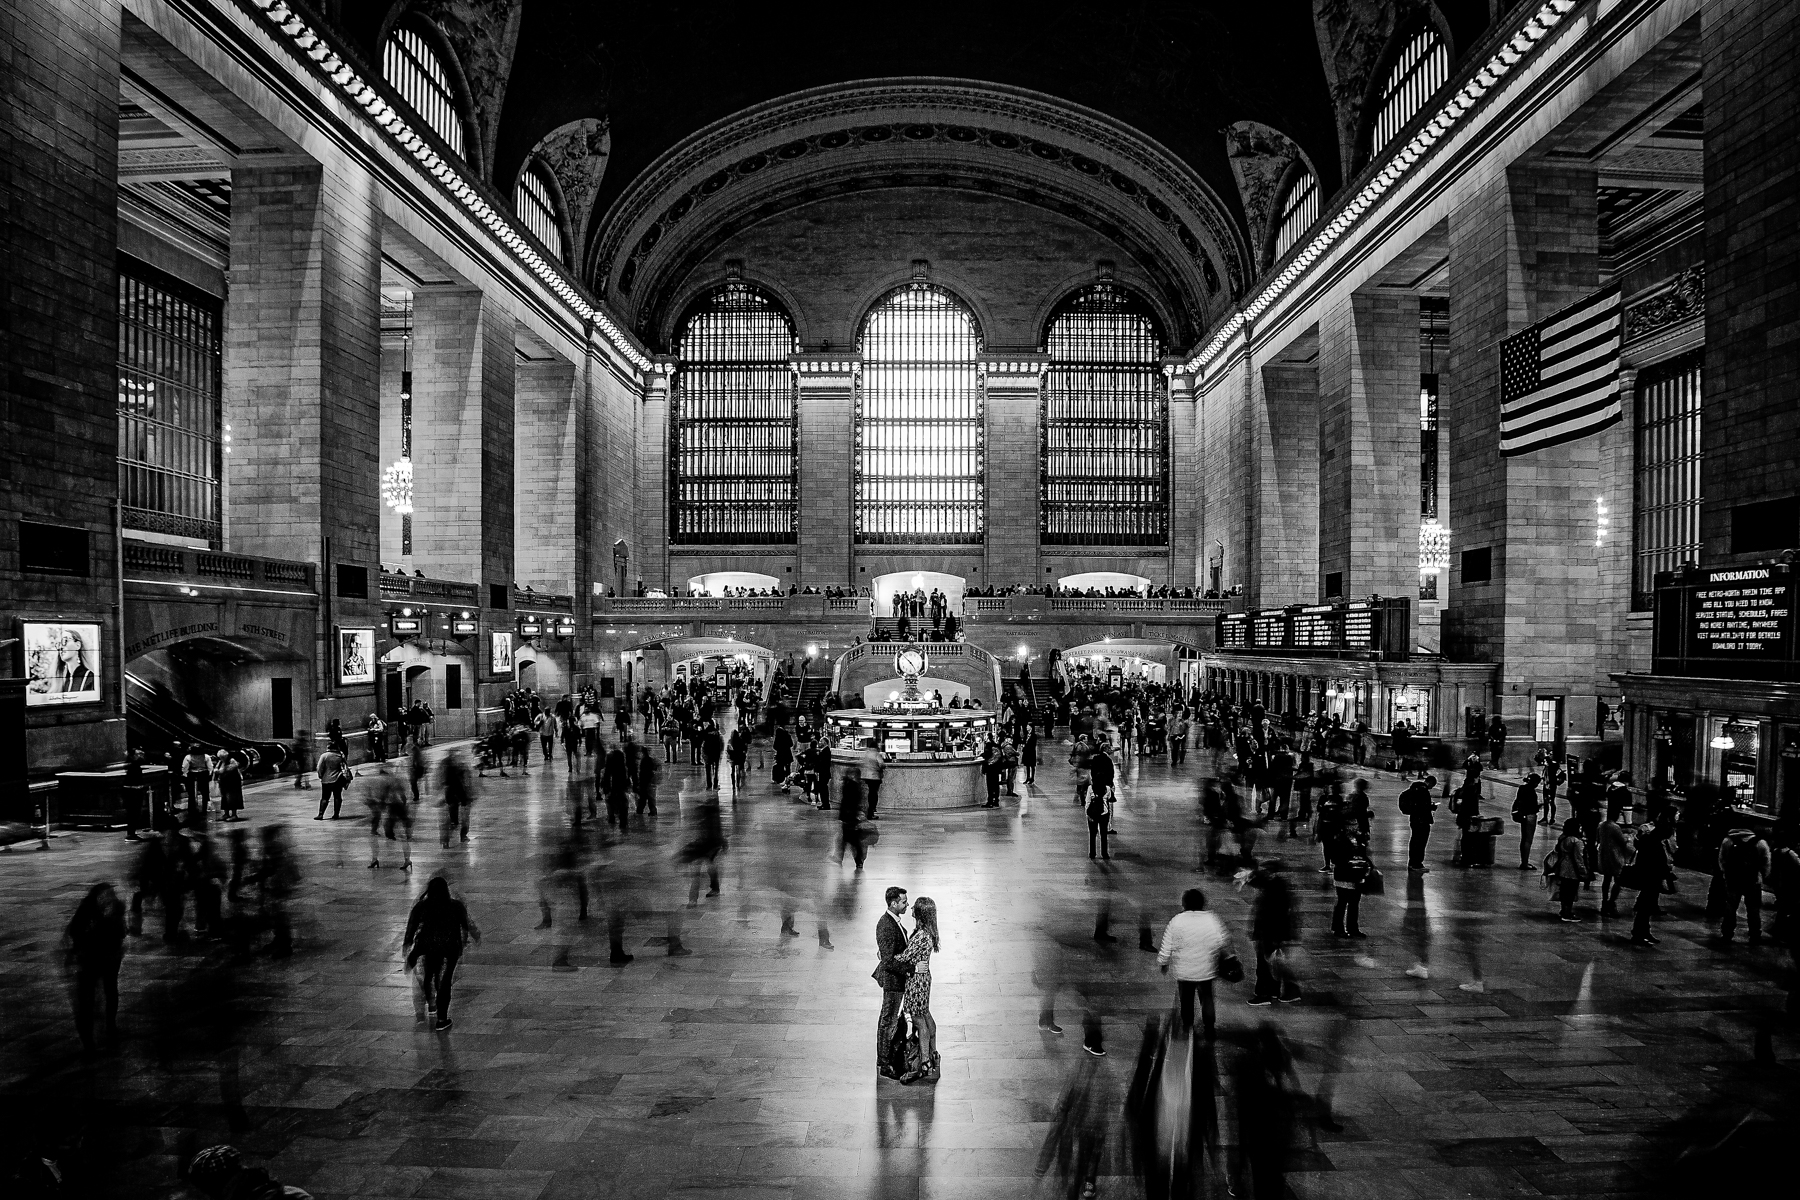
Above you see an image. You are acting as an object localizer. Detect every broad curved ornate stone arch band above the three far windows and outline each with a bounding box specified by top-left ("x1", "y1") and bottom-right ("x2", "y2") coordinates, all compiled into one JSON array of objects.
[{"x1": 587, "y1": 79, "x2": 1251, "y2": 345}]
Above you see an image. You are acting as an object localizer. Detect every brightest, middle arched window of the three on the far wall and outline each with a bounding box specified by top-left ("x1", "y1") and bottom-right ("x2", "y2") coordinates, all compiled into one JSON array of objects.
[{"x1": 857, "y1": 282, "x2": 983, "y2": 543}]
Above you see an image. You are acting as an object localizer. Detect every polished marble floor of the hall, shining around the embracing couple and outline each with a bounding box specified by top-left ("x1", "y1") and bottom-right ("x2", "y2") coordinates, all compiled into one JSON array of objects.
[{"x1": 0, "y1": 737, "x2": 1800, "y2": 1200}]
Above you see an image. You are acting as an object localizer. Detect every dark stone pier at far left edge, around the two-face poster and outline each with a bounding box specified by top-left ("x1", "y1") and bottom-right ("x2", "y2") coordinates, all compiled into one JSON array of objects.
[{"x1": 0, "y1": 0, "x2": 124, "y2": 770}]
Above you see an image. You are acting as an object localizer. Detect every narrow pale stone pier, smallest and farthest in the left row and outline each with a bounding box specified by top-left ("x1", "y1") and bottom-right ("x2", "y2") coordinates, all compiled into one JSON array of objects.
[{"x1": 513, "y1": 358, "x2": 581, "y2": 592}]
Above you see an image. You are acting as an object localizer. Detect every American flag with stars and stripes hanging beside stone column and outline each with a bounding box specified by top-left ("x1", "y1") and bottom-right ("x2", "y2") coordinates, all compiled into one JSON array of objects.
[{"x1": 1499, "y1": 288, "x2": 1622, "y2": 459}]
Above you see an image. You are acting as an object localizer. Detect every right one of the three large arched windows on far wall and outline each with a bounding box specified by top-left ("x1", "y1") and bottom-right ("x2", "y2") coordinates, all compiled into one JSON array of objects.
[{"x1": 1040, "y1": 282, "x2": 1168, "y2": 545}]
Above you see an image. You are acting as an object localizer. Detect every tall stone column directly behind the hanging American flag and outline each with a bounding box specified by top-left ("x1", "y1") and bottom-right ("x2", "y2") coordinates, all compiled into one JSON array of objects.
[{"x1": 1440, "y1": 162, "x2": 1624, "y2": 756}]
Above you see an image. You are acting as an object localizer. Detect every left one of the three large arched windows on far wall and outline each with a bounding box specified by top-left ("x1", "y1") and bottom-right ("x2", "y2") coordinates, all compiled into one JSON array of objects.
[{"x1": 670, "y1": 281, "x2": 797, "y2": 543}]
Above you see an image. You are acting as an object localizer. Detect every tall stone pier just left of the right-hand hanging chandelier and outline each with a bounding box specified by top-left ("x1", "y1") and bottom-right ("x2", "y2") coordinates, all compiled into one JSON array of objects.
[{"x1": 1318, "y1": 291, "x2": 1418, "y2": 597}]
